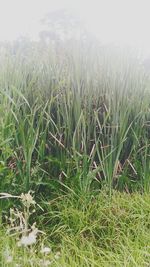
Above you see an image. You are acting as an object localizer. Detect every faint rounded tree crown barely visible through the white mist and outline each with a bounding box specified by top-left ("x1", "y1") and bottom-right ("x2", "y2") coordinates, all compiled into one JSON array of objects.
[{"x1": 39, "y1": 9, "x2": 89, "y2": 42}]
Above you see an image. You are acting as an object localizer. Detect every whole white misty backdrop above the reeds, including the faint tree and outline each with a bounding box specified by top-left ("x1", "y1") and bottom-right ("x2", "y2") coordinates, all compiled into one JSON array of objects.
[{"x1": 0, "y1": 0, "x2": 150, "y2": 57}]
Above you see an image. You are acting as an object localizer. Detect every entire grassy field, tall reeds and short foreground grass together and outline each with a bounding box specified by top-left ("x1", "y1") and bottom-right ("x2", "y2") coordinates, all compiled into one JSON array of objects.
[{"x1": 0, "y1": 42, "x2": 150, "y2": 267}]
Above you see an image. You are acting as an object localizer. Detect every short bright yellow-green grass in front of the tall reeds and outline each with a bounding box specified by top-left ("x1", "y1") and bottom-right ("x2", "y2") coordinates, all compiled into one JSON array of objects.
[{"x1": 0, "y1": 191, "x2": 150, "y2": 267}]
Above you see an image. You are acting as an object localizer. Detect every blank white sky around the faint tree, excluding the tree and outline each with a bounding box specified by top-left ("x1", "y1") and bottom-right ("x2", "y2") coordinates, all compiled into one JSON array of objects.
[{"x1": 0, "y1": 0, "x2": 150, "y2": 53}]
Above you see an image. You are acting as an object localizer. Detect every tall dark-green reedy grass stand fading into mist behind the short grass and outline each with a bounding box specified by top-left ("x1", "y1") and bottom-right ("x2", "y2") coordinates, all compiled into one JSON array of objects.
[{"x1": 0, "y1": 42, "x2": 150, "y2": 193}]
